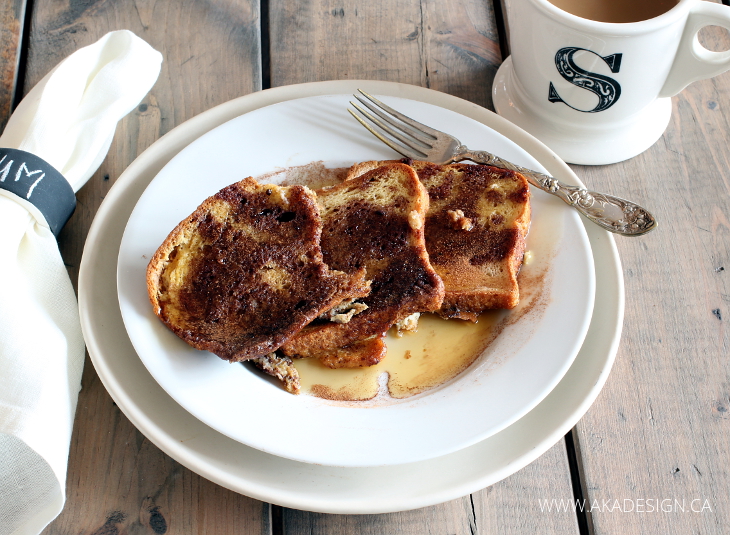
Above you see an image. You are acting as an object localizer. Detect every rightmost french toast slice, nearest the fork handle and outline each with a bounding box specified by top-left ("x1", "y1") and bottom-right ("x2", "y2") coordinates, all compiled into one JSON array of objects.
[{"x1": 347, "y1": 160, "x2": 531, "y2": 321}]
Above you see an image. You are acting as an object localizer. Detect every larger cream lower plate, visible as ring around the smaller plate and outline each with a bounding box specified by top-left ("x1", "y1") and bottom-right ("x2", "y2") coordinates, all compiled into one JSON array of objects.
[{"x1": 79, "y1": 81, "x2": 624, "y2": 514}]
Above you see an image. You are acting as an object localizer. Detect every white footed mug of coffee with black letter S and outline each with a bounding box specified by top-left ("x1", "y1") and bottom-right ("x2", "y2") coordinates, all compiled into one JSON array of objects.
[{"x1": 492, "y1": 0, "x2": 730, "y2": 165}]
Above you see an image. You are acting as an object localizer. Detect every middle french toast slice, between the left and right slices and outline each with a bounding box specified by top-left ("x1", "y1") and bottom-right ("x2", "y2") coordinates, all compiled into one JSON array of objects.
[{"x1": 281, "y1": 162, "x2": 444, "y2": 368}]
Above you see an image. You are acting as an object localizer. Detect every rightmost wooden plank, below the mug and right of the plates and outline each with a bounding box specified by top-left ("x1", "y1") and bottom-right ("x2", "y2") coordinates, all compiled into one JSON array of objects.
[{"x1": 575, "y1": 22, "x2": 730, "y2": 535}]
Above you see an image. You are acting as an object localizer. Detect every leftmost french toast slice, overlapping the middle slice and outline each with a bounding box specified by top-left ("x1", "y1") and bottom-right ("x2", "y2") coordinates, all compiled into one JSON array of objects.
[{"x1": 147, "y1": 178, "x2": 369, "y2": 361}]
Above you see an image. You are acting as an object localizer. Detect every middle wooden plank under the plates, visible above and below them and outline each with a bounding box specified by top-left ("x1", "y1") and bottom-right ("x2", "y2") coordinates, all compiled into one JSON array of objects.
[{"x1": 270, "y1": 0, "x2": 577, "y2": 535}]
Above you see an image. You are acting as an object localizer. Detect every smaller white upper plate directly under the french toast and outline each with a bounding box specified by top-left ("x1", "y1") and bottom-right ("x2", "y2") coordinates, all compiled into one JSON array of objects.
[{"x1": 118, "y1": 95, "x2": 594, "y2": 466}]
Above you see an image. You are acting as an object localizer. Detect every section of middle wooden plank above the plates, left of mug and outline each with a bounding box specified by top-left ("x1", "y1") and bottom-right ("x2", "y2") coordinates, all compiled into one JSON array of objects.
[{"x1": 269, "y1": 0, "x2": 501, "y2": 107}]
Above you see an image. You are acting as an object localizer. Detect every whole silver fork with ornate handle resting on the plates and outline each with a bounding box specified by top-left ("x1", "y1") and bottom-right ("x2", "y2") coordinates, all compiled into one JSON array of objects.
[{"x1": 348, "y1": 89, "x2": 657, "y2": 236}]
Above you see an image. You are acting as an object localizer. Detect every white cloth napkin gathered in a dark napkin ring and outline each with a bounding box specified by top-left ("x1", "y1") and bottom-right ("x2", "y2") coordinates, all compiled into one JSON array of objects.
[{"x1": 0, "y1": 31, "x2": 162, "y2": 535}]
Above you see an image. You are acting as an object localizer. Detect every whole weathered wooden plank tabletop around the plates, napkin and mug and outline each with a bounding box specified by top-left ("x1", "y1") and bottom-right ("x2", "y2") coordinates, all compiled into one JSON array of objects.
[{"x1": 0, "y1": 0, "x2": 730, "y2": 535}]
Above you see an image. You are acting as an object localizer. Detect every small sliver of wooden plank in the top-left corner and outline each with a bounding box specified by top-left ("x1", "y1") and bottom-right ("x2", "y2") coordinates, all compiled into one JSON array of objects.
[{"x1": 0, "y1": 0, "x2": 26, "y2": 132}]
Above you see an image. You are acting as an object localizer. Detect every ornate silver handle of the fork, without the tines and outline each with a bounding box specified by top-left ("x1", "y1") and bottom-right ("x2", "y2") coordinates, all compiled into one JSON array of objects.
[{"x1": 452, "y1": 145, "x2": 657, "y2": 236}]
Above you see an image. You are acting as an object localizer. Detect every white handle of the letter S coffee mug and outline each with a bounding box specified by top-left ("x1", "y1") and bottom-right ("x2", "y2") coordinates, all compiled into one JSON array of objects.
[{"x1": 659, "y1": 2, "x2": 730, "y2": 97}]
